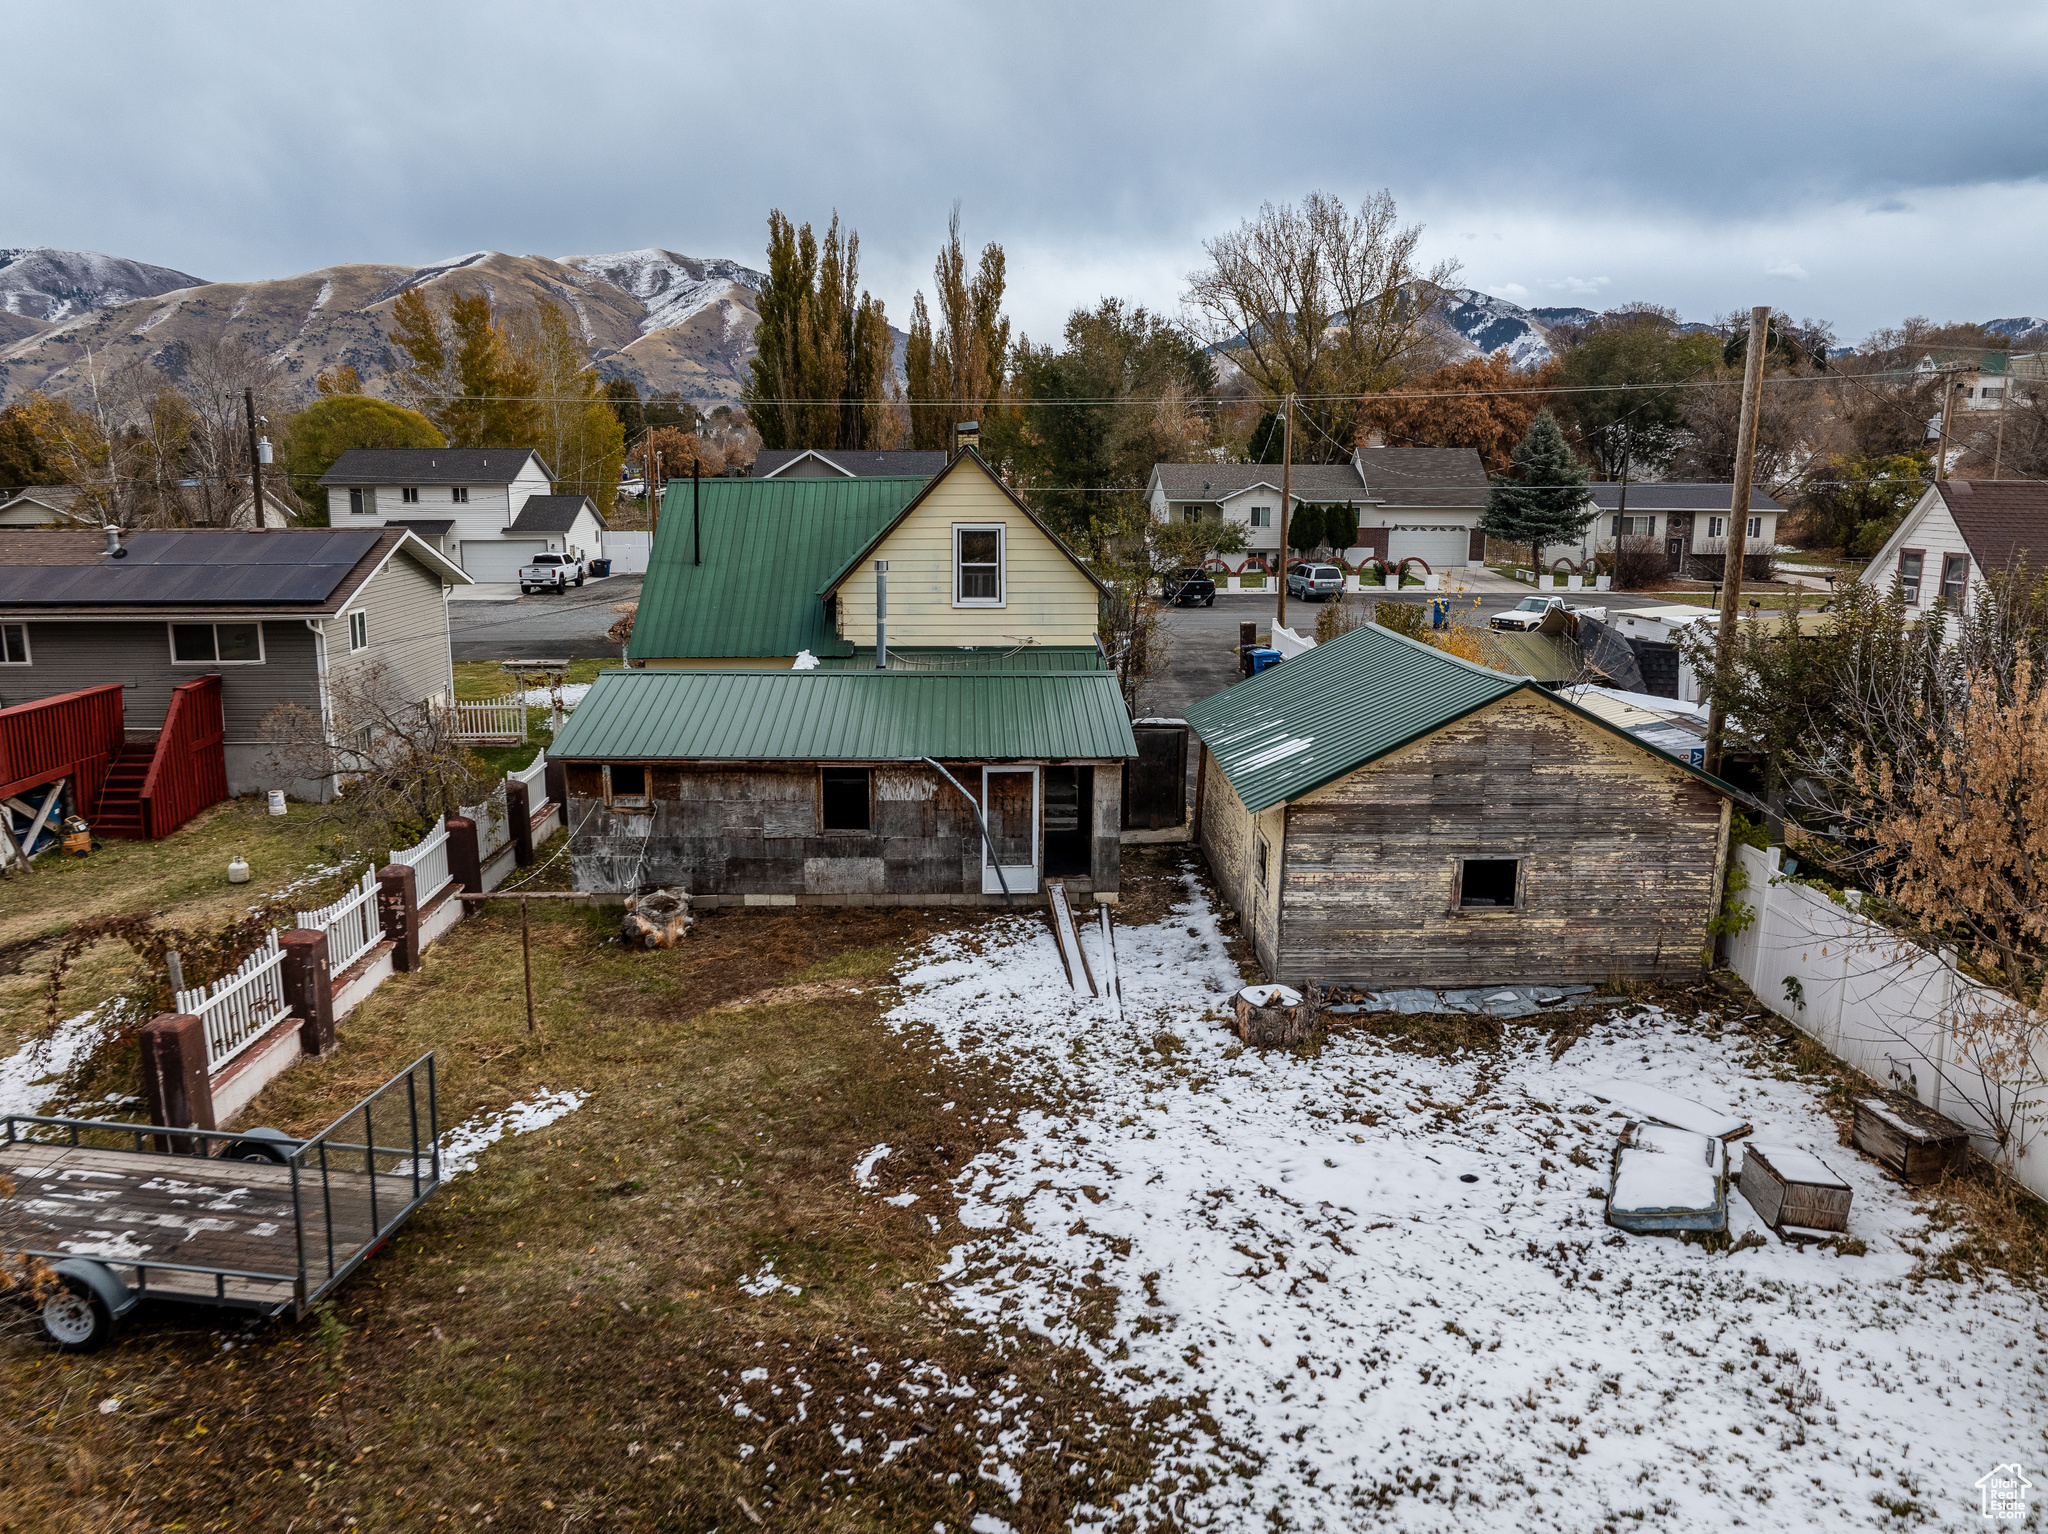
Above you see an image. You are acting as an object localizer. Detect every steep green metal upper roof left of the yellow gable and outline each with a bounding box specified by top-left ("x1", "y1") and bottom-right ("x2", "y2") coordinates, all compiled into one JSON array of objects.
[{"x1": 627, "y1": 475, "x2": 926, "y2": 659}]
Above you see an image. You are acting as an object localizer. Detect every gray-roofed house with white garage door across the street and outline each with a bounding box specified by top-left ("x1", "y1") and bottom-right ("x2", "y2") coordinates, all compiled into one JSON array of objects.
[{"x1": 1145, "y1": 446, "x2": 1487, "y2": 569}]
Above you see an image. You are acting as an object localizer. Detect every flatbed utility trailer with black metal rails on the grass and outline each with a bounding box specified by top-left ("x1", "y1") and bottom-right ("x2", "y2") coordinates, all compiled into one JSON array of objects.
[{"x1": 0, "y1": 1053, "x2": 440, "y2": 1352}]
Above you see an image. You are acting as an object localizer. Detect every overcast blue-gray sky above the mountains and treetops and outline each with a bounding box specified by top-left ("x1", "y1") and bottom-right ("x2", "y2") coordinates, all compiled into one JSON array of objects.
[{"x1": 0, "y1": 0, "x2": 2048, "y2": 340}]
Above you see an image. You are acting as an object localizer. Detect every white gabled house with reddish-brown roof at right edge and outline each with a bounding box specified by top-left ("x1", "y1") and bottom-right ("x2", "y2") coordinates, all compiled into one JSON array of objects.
[{"x1": 1862, "y1": 479, "x2": 2048, "y2": 612}]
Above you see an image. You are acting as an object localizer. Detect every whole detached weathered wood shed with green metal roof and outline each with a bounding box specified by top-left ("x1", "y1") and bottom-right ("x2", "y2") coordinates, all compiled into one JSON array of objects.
[{"x1": 1188, "y1": 625, "x2": 1729, "y2": 987}]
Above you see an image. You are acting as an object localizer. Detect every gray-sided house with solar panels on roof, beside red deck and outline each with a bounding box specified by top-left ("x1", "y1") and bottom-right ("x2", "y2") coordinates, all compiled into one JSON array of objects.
[{"x1": 0, "y1": 526, "x2": 469, "y2": 799}]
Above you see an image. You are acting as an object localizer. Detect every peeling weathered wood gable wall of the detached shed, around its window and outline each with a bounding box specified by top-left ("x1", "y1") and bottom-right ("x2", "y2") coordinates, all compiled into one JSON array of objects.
[{"x1": 1268, "y1": 692, "x2": 1729, "y2": 985}]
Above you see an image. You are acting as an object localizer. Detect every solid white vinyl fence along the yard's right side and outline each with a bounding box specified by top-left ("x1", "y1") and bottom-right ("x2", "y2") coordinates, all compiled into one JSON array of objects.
[{"x1": 1729, "y1": 846, "x2": 2048, "y2": 1198}]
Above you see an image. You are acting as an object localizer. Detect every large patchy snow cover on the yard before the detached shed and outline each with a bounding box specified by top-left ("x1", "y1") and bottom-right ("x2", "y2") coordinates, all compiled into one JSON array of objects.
[{"x1": 880, "y1": 881, "x2": 2048, "y2": 1530}]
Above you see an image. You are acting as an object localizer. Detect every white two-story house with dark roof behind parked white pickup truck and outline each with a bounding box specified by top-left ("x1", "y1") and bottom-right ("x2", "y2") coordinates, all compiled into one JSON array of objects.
[{"x1": 319, "y1": 446, "x2": 604, "y2": 582}]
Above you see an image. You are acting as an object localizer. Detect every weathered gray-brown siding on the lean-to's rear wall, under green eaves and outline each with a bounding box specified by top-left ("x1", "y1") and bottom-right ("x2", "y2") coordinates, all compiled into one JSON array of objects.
[{"x1": 567, "y1": 762, "x2": 1122, "y2": 905}]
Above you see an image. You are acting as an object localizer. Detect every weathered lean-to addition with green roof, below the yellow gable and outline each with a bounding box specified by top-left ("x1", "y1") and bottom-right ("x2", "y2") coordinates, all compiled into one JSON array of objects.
[{"x1": 549, "y1": 668, "x2": 1137, "y2": 905}]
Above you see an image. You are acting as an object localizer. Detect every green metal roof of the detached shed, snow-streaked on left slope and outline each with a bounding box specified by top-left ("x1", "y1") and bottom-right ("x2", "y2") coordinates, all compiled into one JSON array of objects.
[{"x1": 1186, "y1": 623, "x2": 1735, "y2": 813}]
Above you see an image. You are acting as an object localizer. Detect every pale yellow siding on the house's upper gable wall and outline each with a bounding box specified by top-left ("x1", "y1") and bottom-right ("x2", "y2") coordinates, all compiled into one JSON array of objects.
[{"x1": 838, "y1": 465, "x2": 1100, "y2": 645}]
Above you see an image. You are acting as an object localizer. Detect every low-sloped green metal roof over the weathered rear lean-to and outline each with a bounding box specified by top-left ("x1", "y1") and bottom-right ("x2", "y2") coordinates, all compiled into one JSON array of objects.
[{"x1": 547, "y1": 668, "x2": 1139, "y2": 762}]
